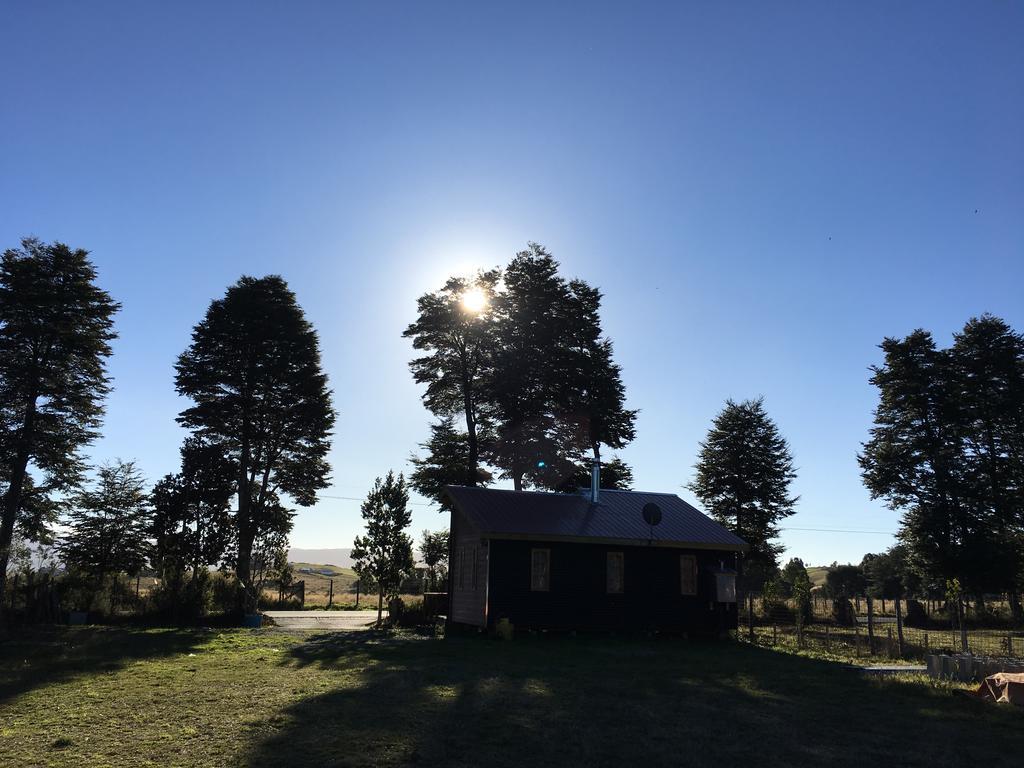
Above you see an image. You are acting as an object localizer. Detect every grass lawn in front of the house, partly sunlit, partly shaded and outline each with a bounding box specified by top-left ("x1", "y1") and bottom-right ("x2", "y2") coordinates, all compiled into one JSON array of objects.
[{"x1": 0, "y1": 628, "x2": 1024, "y2": 768}]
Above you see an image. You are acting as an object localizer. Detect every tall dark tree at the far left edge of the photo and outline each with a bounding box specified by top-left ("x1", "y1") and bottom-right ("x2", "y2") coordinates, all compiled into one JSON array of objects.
[{"x1": 0, "y1": 239, "x2": 119, "y2": 618}]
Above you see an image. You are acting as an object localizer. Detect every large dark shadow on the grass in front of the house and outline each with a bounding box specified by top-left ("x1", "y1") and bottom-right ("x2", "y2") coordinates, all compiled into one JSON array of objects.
[{"x1": 248, "y1": 632, "x2": 1024, "y2": 768}]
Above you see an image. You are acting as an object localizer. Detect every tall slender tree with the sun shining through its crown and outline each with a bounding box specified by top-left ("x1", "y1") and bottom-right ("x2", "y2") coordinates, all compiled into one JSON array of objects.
[{"x1": 402, "y1": 269, "x2": 501, "y2": 487}]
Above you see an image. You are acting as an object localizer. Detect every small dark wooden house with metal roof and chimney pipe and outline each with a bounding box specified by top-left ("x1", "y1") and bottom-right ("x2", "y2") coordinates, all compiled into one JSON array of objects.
[{"x1": 445, "y1": 468, "x2": 748, "y2": 635}]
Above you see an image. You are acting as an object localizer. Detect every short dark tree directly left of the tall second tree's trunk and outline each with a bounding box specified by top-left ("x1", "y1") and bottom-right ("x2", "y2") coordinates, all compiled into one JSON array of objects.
[{"x1": 151, "y1": 437, "x2": 237, "y2": 607}]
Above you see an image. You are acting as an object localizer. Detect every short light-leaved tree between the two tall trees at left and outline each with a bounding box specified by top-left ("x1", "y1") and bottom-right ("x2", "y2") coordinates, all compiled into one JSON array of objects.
[{"x1": 61, "y1": 461, "x2": 151, "y2": 608}]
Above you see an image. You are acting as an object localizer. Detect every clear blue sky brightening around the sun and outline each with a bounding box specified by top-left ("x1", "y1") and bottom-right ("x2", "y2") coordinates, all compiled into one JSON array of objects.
[{"x1": 0, "y1": 0, "x2": 1024, "y2": 564}]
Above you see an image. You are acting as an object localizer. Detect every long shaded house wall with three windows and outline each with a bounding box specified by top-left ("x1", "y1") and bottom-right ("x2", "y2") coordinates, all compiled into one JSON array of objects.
[{"x1": 487, "y1": 540, "x2": 736, "y2": 635}]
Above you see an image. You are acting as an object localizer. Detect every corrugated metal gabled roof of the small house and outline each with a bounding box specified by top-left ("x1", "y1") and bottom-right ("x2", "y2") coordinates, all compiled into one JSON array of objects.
[{"x1": 444, "y1": 485, "x2": 748, "y2": 552}]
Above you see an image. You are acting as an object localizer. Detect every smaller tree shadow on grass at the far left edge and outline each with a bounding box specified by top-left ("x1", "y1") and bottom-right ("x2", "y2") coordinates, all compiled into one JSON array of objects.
[{"x1": 0, "y1": 627, "x2": 203, "y2": 705}]
